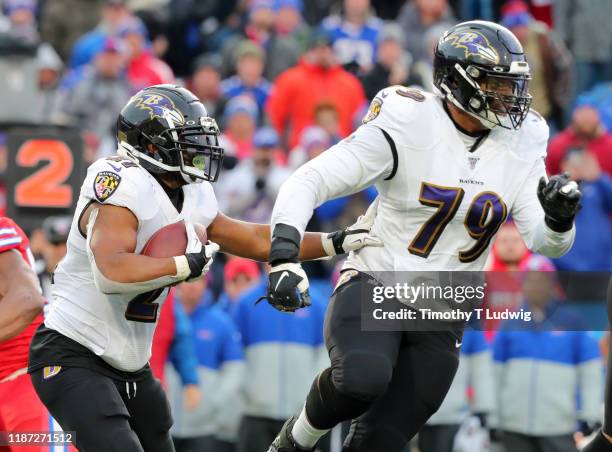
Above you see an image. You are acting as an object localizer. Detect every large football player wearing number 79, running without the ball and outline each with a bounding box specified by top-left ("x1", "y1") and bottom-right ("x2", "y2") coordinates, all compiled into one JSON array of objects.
[{"x1": 267, "y1": 21, "x2": 580, "y2": 452}]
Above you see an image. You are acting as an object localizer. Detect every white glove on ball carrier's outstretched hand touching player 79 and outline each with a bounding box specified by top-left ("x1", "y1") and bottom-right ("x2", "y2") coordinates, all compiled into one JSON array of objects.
[{"x1": 321, "y1": 197, "x2": 383, "y2": 256}]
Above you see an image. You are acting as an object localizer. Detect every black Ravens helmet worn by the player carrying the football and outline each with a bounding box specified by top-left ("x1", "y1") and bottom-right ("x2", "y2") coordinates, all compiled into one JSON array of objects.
[{"x1": 118, "y1": 85, "x2": 224, "y2": 184}]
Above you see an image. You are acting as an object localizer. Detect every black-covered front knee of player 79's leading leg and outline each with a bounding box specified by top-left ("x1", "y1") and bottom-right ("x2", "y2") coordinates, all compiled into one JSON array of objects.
[{"x1": 332, "y1": 350, "x2": 393, "y2": 402}]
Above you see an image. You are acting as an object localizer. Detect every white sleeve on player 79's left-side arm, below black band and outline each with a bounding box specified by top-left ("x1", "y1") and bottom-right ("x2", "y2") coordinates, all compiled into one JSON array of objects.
[{"x1": 272, "y1": 124, "x2": 394, "y2": 236}]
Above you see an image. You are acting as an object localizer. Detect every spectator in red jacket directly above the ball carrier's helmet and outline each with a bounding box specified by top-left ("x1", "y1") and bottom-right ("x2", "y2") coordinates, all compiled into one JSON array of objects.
[{"x1": 119, "y1": 18, "x2": 174, "y2": 91}]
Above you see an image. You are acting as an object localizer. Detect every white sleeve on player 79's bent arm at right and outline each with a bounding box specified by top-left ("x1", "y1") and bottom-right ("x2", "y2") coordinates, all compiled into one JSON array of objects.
[{"x1": 512, "y1": 158, "x2": 576, "y2": 258}]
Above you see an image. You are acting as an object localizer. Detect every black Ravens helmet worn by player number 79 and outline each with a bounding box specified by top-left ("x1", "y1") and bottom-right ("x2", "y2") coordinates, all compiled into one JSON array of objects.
[{"x1": 434, "y1": 21, "x2": 531, "y2": 130}]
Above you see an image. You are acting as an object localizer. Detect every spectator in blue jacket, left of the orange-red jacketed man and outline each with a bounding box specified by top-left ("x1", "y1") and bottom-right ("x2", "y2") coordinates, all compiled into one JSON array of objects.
[{"x1": 221, "y1": 39, "x2": 272, "y2": 119}]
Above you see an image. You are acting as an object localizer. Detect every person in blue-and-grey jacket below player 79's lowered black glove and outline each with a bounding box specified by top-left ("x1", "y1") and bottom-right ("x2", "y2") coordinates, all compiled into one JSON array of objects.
[{"x1": 234, "y1": 275, "x2": 329, "y2": 452}]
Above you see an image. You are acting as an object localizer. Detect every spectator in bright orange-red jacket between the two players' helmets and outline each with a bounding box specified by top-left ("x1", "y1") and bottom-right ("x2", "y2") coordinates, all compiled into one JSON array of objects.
[{"x1": 267, "y1": 32, "x2": 366, "y2": 148}]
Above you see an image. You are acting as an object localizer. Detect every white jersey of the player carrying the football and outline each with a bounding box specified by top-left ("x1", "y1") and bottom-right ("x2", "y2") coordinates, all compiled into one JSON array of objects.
[{"x1": 45, "y1": 157, "x2": 217, "y2": 372}]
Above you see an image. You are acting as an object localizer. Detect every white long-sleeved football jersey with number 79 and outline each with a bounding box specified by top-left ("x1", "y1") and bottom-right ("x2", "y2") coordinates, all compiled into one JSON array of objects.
[{"x1": 272, "y1": 86, "x2": 574, "y2": 271}]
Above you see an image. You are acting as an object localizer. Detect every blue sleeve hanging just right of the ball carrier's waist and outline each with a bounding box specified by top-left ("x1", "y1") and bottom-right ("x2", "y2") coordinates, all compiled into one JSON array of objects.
[{"x1": 170, "y1": 302, "x2": 198, "y2": 386}]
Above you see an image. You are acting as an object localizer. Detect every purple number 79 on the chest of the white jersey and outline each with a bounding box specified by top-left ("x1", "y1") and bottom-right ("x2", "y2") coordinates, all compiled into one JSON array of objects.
[{"x1": 408, "y1": 182, "x2": 508, "y2": 262}]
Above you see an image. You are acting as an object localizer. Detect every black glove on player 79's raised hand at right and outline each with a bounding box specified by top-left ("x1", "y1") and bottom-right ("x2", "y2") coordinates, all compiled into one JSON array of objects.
[{"x1": 538, "y1": 173, "x2": 582, "y2": 232}]
